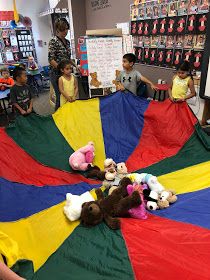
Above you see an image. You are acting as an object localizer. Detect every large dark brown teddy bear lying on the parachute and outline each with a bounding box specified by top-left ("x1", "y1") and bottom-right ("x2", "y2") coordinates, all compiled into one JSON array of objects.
[{"x1": 81, "y1": 178, "x2": 142, "y2": 229}]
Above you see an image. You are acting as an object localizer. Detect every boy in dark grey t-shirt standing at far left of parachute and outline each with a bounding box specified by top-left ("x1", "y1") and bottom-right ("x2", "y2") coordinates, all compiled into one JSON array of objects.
[{"x1": 10, "y1": 67, "x2": 33, "y2": 115}]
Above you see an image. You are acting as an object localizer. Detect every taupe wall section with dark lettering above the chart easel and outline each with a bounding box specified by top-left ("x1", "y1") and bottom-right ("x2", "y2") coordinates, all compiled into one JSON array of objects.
[{"x1": 85, "y1": 0, "x2": 133, "y2": 29}]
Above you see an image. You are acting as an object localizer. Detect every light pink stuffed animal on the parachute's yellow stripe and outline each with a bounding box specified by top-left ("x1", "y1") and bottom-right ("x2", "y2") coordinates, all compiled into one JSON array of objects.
[{"x1": 69, "y1": 142, "x2": 95, "y2": 171}]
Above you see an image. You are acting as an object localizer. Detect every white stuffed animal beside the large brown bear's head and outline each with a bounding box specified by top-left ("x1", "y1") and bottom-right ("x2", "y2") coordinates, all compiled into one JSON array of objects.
[{"x1": 63, "y1": 192, "x2": 95, "y2": 222}]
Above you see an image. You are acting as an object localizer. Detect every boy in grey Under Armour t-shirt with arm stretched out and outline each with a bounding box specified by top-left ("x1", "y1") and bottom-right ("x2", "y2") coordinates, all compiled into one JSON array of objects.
[{"x1": 117, "y1": 53, "x2": 157, "y2": 95}]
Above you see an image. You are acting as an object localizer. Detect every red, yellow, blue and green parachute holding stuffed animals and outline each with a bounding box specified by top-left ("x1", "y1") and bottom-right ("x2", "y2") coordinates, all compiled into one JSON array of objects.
[{"x1": 0, "y1": 92, "x2": 210, "y2": 280}]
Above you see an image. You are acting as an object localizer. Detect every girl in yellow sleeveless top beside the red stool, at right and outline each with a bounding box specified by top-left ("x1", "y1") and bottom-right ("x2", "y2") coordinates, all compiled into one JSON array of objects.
[{"x1": 169, "y1": 61, "x2": 196, "y2": 102}]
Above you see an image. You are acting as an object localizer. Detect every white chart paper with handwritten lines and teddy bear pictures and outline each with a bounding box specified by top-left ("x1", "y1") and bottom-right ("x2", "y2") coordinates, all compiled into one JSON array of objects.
[{"x1": 86, "y1": 37, "x2": 123, "y2": 97}]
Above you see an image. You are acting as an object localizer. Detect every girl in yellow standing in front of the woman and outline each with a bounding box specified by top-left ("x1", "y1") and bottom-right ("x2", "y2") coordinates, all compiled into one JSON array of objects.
[{"x1": 58, "y1": 60, "x2": 78, "y2": 106}]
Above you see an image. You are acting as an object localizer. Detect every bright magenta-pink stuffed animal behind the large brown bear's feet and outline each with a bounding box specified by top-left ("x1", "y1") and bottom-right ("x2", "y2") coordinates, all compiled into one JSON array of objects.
[{"x1": 127, "y1": 184, "x2": 147, "y2": 220}]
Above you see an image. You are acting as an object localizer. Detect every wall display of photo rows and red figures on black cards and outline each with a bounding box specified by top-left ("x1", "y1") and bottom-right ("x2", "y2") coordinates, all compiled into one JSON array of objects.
[{"x1": 130, "y1": 0, "x2": 209, "y2": 71}]
